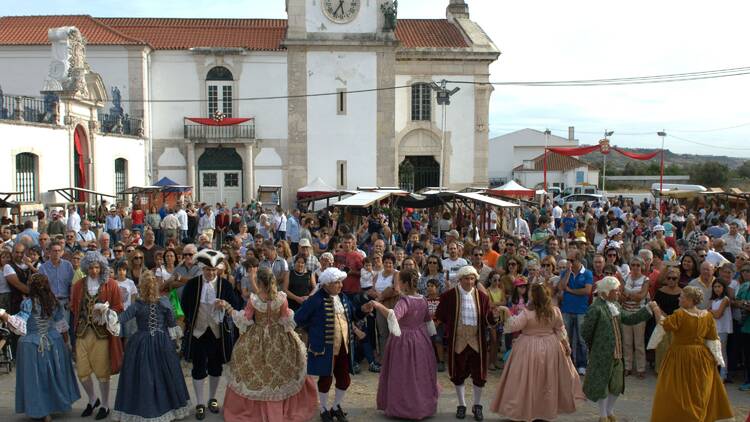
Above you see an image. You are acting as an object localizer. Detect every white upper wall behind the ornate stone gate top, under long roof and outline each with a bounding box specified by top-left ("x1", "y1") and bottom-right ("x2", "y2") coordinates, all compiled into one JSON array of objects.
[{"x1": 0, "y1": 45, "x2": 130, "y2": 113}]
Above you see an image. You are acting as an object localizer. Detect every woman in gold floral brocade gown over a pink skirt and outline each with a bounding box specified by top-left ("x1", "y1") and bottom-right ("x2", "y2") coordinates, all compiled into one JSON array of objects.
[{"x1": 223, "y1": 269, "x2": 318, "y2": 422}]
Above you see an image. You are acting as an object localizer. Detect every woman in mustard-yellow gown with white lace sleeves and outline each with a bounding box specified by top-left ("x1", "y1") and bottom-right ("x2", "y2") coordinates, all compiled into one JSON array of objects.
[{"x1": 651, "y1": 286, "x2": 732, "y2": 422}]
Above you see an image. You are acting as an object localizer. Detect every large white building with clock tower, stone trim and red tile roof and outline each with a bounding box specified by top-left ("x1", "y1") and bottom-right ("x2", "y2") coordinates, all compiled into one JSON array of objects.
[{"x1": 0, "y1": 0, "x2": 500, "y2": 206}]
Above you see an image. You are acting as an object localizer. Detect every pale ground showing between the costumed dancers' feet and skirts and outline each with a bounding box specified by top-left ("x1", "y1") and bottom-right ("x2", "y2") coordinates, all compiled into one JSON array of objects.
[{"x1": 0, "y1": 367, "x2": 750, "y2": 422}]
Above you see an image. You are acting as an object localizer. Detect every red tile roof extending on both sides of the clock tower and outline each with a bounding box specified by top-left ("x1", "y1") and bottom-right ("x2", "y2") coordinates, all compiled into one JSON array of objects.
[{"x1": 0, "y1": 15, "x2": 468, "y2": 51}]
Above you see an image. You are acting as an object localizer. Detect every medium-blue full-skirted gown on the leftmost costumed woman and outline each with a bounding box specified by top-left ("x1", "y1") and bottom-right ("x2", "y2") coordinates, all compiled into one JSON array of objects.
[{"x1": 15, "y1": 299, "x2": 81, "y2": 418}]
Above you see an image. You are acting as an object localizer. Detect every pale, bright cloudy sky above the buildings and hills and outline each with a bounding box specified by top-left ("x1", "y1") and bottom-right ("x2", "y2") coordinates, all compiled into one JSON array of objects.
[{"x1": 8, "y1": 0, "x2": 750, "y2": 158}]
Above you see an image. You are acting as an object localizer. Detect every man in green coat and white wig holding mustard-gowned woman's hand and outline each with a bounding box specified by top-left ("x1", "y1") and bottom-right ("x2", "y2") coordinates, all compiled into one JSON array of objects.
[{"x1": 581, "y1": 277, "x2": 661, "y2": 422}]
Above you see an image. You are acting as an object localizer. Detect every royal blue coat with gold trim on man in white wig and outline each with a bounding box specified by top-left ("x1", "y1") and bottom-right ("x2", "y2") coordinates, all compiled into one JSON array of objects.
[{"x1": 294, "y1": 288, "x2": 363, "y2": 376}]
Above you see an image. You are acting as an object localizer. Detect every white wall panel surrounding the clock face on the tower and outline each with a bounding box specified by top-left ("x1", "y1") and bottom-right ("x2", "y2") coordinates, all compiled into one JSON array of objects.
[{"x1": 305, "y1": 0, "x2": 381, "y2": 33}]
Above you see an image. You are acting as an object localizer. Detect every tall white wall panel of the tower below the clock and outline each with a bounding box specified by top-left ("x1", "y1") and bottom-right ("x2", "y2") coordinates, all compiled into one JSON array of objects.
[{"x1": 306, "y1": 50, "x2": 377, "y2": 188}]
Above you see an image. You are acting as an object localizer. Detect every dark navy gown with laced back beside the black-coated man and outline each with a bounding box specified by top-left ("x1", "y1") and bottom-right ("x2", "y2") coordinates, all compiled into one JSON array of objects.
[{"x1": 112, "y1": 298, "x2": 191, "y2": 422}]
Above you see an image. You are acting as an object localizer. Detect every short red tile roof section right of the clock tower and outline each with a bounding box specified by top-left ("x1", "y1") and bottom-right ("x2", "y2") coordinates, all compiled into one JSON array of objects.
[{"x1": 396, "y1": 19, "x2": 468, "y2": 48}]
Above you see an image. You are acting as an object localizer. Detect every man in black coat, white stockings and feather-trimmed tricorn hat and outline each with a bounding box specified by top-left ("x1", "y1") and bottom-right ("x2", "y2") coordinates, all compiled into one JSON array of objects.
[{"x1": 180, "y1": 249, "x2": 242, "y2": 420}]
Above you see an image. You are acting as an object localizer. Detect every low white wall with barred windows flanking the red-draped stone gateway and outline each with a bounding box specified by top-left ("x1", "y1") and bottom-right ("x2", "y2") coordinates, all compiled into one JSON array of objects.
[{"x1": 0, "y1": 121, "x2": 146, "y2": 200}]
